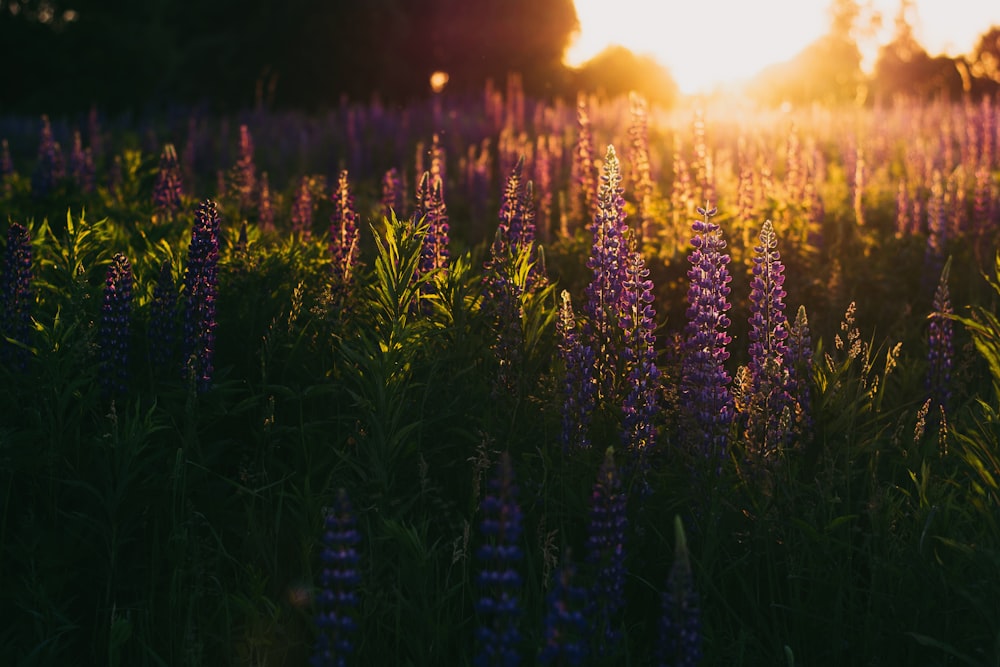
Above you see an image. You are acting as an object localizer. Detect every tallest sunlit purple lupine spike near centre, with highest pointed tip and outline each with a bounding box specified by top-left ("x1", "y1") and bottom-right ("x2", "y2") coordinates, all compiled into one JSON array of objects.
[{"x1": 584, "y1": 145, "x2": 629, "y2": 399}]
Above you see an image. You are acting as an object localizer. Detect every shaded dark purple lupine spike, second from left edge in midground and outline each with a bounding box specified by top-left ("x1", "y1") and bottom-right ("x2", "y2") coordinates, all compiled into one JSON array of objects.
[{"x1": 98, "y1": 253, "x2": 132, "y2": 397}]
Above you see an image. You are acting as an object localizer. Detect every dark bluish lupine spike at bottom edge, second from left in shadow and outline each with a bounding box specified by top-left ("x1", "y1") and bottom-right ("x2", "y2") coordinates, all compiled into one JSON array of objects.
[{"x1": 474, "y1": 452, "x2": 523, "y2": 667}]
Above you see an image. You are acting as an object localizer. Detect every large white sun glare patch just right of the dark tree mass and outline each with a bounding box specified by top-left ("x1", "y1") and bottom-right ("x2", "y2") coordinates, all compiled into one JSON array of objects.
[{"x1": 565, "y1": 0, "x2": 826, "y2": 94}]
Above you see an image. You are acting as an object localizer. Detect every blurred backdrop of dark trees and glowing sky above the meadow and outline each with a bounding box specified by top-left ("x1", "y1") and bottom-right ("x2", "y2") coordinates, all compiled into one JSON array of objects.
[{"x1": 0, "y1": 0, "x2": 1000, "y2": 113}]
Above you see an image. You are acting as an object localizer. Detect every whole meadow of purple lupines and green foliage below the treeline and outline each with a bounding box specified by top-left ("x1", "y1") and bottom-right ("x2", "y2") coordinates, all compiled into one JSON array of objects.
[{"x1": 0, "y1": 86, "x2": 1000, "y2": 667}]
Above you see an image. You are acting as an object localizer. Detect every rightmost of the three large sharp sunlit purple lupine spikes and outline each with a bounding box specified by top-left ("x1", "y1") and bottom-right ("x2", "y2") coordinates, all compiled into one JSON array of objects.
[{"x1": 747, "y1": 220, "x2": 794, "y2": 457}]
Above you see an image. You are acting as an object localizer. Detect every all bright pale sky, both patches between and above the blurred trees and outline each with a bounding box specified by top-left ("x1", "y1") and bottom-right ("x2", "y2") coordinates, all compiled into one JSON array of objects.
[{"x1": 566, "y1": 0, "x2": 1000, "y2": 93}]
